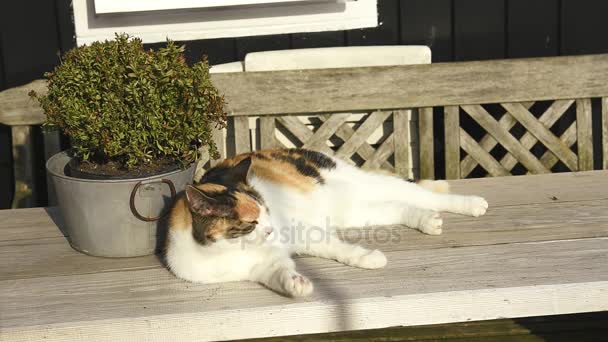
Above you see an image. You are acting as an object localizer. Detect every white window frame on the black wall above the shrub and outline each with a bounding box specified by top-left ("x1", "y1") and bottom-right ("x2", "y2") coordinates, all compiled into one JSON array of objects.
[{"x1": 72, "y1": 0, "x2": 378, "y2": 45}]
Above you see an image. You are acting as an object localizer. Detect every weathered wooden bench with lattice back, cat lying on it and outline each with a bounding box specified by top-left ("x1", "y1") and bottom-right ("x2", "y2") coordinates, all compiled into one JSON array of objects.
[{"x1": 0, "y1": 55, "x2": 608, "y2": 341}]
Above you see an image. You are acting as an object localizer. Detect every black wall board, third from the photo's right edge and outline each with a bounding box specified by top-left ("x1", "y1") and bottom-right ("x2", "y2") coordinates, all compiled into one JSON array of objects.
[{"x1": 453, "y1": 0, "x2": 506, "y2": 61}]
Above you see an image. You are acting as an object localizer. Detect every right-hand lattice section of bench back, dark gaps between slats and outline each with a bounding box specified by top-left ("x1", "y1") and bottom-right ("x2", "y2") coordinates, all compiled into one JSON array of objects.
[{"x1": 445, "y1": 99, "x2": 593, "y2": 179}]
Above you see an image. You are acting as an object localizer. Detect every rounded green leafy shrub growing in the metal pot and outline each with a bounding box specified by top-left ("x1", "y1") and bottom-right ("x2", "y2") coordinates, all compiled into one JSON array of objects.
[{"x1": 30, "y1": 34, "x2": 226, "y2": 168}]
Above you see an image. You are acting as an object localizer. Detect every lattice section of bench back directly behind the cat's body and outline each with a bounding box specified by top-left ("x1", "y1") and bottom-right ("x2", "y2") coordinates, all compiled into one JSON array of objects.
[{"x1": 227, "y1": 110, "x2": 417, "y2": 177}]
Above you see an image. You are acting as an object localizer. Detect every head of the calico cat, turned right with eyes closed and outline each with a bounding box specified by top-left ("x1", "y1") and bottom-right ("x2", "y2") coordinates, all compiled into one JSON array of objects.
[{"x1": 185, "y1": 160, "x2": 272, "y2": 245}]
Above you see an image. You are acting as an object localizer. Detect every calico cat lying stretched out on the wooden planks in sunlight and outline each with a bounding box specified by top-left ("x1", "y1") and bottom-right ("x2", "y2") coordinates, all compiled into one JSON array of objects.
[{"x1": 165, "y1": 149, "x2": 488, "y2": 297}]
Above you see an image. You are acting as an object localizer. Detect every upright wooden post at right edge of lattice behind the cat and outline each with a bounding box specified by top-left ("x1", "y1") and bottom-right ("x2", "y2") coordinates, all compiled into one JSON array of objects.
[{"x1": 418, "y1": 107, "x2": 435, "y2": 179}]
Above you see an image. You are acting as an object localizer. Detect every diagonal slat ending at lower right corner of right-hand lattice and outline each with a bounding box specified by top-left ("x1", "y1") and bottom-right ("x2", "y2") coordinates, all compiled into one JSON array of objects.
[{"x1": 502, "y1": 103, "x2": 580, "y2": 171}]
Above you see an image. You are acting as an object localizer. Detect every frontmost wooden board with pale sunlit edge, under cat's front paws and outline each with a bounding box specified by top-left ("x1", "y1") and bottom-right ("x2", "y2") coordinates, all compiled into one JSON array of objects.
[{"x1": 0, "y1": 239, "x2": 608, "y2": 341}]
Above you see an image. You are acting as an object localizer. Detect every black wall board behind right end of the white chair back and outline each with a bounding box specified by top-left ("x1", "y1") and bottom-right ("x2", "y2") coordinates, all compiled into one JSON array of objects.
[{"x1": 400, "y1": 0, "x2": 454, "y2": 63}]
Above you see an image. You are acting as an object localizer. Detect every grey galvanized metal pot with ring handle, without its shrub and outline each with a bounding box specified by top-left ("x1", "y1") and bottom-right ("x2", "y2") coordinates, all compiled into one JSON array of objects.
[{"x1": 46, "y1": 152, "x2": 195, "y2": 257}]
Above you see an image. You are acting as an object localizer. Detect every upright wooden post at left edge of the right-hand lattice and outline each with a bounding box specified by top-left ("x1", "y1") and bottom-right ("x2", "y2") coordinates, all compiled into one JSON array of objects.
[{"x1": 444, "y1": 106, "x2": 458, "y2": 179}]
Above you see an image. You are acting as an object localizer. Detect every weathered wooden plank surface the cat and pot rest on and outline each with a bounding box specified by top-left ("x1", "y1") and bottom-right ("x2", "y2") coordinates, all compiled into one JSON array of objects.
[{"x1": 0, "y1": 171, "x2": 608, "y2": 342}]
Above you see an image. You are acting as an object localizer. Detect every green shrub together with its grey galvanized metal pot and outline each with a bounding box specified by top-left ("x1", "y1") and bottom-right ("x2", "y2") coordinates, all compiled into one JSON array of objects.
[{"x1": 30, "y1": 34, "x2": 226, "y2": 257}]
